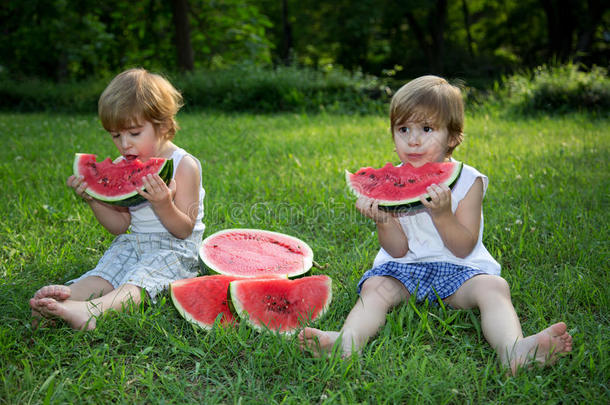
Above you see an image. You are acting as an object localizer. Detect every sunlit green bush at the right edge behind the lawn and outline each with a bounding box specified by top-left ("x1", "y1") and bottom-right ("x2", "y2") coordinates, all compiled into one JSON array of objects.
[{"x1": 498, "y1": 64, "x2": 610, "y2": 113}]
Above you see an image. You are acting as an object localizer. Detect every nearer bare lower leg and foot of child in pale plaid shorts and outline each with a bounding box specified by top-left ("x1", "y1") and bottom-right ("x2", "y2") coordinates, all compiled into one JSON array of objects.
[{"x1": 38, "y1": 284, "x2": 142, "y2": 329}]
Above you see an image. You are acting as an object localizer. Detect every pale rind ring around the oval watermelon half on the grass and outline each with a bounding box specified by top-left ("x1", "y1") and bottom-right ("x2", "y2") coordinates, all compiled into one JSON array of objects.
[{"x1": 198, "y1": 228, "x2": 313, "y2": 278}]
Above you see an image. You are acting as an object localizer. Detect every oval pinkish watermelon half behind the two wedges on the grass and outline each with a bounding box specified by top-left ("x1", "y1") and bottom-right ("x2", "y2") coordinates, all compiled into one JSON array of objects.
[{"x1": 199, "y1": 229, "x2": 313, "y2": 277}]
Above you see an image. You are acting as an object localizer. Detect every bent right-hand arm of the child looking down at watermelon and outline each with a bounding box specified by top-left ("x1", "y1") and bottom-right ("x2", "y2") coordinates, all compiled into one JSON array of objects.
[{"x1": 138, "y1": 156, "x2": 201, "y2": 239}]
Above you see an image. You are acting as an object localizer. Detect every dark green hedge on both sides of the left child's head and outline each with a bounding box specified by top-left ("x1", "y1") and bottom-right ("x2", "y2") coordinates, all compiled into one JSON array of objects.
[{"x1": 0, "y1": 65, "x2": 388, "y2": 113}]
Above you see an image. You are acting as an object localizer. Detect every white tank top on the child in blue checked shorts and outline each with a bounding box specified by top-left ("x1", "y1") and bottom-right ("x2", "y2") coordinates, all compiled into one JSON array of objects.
[{"x1": 373, "y1": 161, "x2": 500, "y2": 275}]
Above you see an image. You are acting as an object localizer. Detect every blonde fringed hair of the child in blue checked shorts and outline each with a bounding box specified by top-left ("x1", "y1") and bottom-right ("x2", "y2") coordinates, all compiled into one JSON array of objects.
[{"x1": 390, "y1": 75, "x2": 464, "y2": 157}]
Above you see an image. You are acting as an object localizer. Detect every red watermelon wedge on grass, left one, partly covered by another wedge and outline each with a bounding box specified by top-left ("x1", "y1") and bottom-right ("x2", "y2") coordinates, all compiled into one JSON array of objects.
[{"x1": 170, "y1": 275, "x2": 241, "y2": 329}]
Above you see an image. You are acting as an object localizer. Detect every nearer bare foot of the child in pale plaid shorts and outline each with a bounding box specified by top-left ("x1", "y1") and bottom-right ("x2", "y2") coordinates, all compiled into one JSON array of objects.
[{"x1": 37, "y1": 298, "x2": 96, "y2": 330}]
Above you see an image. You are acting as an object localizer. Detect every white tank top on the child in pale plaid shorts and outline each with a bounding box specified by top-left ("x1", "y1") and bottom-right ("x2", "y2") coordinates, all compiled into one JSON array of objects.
[{"x1": 129, "y1": 148, "x2": 205, "y2": 233}]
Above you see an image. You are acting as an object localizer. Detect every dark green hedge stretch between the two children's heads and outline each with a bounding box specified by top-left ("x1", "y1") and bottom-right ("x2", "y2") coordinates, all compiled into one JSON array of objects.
[{"x1": 176, "y1": 66, "x2": 386, "y2": 112}]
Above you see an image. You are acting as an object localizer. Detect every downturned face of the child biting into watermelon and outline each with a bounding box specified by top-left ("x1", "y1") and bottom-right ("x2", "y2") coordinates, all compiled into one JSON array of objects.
[{"x1": 110, "y1": 120, "x2": 165, "y2": 162}]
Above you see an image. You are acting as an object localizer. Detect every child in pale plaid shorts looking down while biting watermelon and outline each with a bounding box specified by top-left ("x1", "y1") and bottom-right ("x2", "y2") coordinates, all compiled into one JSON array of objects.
[{"x1": 30, "y1": 69, "x2": 205, "y2": 329}]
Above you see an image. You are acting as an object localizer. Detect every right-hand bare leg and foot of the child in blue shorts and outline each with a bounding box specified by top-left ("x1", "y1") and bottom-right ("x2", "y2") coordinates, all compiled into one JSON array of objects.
[{"x1": 445, "y1": 274, "x2": 572, "y2": 374}]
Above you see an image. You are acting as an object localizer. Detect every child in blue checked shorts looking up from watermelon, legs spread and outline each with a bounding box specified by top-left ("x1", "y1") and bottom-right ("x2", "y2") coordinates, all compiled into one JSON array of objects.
[{"x1": 299, "y1": 76, "x2": 572, "y2": 373}]
